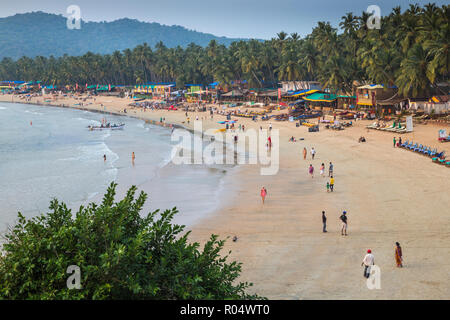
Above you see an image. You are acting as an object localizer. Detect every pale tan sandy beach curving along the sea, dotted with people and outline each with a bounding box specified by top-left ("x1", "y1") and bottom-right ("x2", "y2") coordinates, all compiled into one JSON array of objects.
[{"x1": 0, "y1": 95, "x2": 450, "y2": 299}]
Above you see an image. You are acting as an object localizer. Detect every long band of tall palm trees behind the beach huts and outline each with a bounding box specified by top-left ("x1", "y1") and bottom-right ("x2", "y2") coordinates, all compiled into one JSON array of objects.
[{"x1": 0, "y1": 4, "x2": 450, "y2": 96}]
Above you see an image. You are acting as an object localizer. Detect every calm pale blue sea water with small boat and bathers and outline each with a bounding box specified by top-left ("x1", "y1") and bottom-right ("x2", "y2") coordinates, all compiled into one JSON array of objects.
[{"x1": 0, "y1": 103, "x2": 231, "y2": 232}]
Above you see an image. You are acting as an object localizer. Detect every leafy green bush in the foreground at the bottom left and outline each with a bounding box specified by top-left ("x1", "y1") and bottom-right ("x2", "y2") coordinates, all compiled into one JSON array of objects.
[{"x1": 0, "y1": 183, "x2": 258, "y2": 299}]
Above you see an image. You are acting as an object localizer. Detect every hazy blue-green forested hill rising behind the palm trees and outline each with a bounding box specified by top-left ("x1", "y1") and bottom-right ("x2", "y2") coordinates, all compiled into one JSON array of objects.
[{"x1": 0, "y1": 12, "x2": 243, "y2": 59}]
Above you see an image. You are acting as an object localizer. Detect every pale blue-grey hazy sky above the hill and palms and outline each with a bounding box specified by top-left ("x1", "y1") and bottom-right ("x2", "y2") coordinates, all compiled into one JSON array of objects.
[{"x1": 0, "y1": 0, "x2": 448, "y2": 39}]
